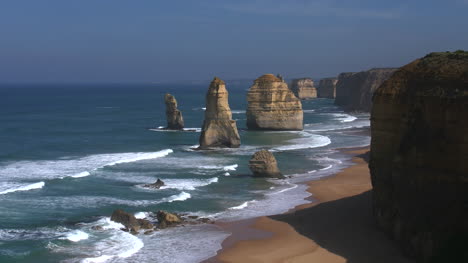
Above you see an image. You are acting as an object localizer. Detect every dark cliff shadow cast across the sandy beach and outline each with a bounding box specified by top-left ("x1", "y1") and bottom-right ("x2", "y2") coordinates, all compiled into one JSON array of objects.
[{"x1": 271, "y1": 191, "x2": 413, "y2": 263}]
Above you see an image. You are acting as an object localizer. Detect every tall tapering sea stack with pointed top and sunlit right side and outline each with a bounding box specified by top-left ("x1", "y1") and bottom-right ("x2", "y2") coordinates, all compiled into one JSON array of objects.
[{"x1": 200, "y1": 77, "x2": 240, "y2": 149}]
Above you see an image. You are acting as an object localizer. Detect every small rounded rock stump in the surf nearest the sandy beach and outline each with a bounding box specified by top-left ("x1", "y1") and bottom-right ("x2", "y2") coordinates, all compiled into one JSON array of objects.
[{"x1": 249, "y1": 150, "x2": 283, "y2": 178}]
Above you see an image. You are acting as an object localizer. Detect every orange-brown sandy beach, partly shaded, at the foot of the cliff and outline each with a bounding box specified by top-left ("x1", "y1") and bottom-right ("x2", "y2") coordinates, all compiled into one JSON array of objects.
[{"x1": 205, "y1": 148, "x2": 412, "y2": 263}]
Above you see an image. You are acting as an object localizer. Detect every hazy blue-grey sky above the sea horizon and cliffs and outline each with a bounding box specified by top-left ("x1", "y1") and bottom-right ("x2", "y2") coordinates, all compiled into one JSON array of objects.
[{"x1": 0, "y1": 0, "x2": 468, "y2": 83}]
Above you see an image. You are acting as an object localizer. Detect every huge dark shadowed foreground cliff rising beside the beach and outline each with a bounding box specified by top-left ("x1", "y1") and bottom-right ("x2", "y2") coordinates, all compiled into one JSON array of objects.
[{"x1": 369, "y1": 51, "x2": 468, "y2": 262}]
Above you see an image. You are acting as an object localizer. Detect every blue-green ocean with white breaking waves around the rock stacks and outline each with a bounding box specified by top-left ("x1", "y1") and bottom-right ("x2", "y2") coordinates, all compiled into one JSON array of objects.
[{"x1": 0, "y1": 82, "x2": 370, "y2": 263}]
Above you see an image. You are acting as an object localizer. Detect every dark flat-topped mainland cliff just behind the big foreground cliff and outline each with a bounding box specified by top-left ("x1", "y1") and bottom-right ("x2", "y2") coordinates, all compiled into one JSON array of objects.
[{"x1": 335, "y1": 68, "x2": 397, "y2": 112}]
